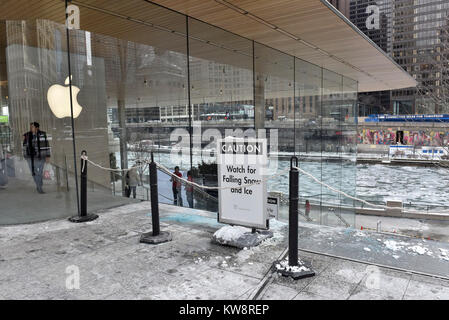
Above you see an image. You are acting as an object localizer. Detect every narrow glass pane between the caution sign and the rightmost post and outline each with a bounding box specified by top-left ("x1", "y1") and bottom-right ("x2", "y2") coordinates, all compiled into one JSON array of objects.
[{"x1": 254, "y1": 43, "x2": 295, "y2": 218}]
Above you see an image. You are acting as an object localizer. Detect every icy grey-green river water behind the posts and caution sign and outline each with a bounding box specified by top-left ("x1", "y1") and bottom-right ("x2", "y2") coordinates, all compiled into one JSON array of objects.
[{"x1": 122, "y1": 153, "x2": 449, "y2": 210}]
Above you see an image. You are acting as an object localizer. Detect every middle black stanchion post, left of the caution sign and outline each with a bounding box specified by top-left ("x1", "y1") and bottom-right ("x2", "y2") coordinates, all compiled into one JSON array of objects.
[{"x1": 140, "y1": 152, "x2": 172, "y2": 244}]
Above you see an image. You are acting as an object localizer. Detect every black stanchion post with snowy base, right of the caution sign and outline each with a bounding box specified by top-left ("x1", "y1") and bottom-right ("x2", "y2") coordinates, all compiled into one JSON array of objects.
[{"x1": 273, "y1": 157, "x2": 315, "y2": 280}]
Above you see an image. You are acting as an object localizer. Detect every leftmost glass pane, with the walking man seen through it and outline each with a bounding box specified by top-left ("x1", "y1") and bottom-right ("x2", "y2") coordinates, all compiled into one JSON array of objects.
[{"x1": 0, "y1": 1, "x2": 85, "y2": 224}]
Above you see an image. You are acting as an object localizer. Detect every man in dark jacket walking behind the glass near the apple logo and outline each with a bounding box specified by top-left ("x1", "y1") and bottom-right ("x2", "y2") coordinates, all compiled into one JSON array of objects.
[{"x1": 23, "y1": 122, "x2": 50, "y2": 193}]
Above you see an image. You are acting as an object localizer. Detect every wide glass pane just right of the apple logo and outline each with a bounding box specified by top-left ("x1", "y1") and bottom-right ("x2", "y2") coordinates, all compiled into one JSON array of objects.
[{"x1": 71, "y1": 0, "x2": 190, "y2": 203}]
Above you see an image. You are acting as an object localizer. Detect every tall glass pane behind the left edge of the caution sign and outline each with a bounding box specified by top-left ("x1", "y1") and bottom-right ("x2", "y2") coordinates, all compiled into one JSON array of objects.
[{"x1": 189, "y1": 18, "x2": 255, "y2": 212}]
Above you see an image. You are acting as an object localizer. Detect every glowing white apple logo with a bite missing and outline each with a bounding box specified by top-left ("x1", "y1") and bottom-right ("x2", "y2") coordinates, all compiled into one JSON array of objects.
[{"x1": 47, "y1": 77, "x2": 83, "y2": 118}]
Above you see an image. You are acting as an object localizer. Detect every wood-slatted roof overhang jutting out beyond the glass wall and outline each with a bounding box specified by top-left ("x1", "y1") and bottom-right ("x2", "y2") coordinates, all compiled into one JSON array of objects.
[{"x1": 152, "y1": 0, "x2": 417, "y2": 92}]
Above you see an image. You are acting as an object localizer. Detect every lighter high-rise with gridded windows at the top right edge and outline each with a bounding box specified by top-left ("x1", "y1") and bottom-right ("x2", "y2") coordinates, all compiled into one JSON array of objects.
[{"x1": 392, "y1": 0, "x2": 449, "y2": 113}]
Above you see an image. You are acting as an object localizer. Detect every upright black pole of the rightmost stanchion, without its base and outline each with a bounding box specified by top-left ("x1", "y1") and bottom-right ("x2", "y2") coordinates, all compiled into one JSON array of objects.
[{"x1": 288, "y1": 157, "x2": 299, "y2": 266}]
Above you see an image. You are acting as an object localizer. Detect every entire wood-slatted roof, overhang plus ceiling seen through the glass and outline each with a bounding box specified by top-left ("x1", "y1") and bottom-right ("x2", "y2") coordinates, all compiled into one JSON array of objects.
[{"x1": 0, "y1": 0, "x2": 416, "y2": 92}]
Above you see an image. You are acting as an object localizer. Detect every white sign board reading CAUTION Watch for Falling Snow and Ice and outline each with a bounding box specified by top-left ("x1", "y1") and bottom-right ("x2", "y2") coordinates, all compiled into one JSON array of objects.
[{"x1": 217, "y1": 137, "x2": 268, "y2": 229}]
